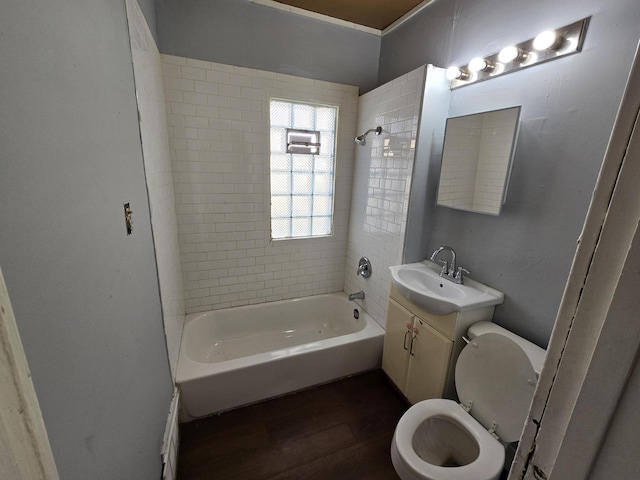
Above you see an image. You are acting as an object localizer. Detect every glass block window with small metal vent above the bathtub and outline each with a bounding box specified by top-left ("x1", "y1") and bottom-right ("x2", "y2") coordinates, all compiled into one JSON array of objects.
[{"x1": 270, "y1": 100, "x2": 338, "y2": 239}]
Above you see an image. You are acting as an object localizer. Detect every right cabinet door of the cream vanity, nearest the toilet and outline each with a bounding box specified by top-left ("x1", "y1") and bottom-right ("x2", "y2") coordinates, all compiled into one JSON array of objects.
[{"x1": 405, "y1": 317, "x2": 453, "y2": 404}]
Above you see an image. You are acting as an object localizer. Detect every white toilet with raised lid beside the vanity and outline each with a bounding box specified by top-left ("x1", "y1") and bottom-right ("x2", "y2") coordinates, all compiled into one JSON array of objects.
[{"x1": 391, "y1": 322, "x2": 545, "y2": 480}]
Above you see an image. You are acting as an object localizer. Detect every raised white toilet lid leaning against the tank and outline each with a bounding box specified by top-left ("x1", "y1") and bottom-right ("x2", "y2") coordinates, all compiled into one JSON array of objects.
[{"x1": 456, "y1": 333, "x2": 536, "y2": 443}]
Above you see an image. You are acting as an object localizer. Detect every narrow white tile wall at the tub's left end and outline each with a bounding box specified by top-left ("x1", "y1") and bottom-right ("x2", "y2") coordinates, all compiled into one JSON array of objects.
[{"x1": 127, "y1": 0, "x2": 185, "y2": 378}]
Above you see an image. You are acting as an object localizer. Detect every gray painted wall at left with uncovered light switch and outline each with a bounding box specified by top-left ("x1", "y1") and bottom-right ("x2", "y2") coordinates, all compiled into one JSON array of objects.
[{"x1": 0, "y1": 0, "x2": 172, "y2": 480}]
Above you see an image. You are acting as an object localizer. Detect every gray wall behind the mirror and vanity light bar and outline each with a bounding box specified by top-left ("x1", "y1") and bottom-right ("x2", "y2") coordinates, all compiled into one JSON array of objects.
[{"x1": 379, "y1": 0, "x2": 640, "y2": 346}]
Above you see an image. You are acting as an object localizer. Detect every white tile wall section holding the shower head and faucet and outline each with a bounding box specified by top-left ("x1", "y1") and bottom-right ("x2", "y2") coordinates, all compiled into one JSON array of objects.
[{"x1": 345, "y1": 67, "x2": 425, "y2": 327}]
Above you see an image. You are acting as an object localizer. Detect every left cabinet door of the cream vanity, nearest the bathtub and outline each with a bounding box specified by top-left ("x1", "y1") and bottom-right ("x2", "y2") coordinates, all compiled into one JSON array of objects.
[{"x1": 382, "y1": 299, "x2": 413, "y2": 393}]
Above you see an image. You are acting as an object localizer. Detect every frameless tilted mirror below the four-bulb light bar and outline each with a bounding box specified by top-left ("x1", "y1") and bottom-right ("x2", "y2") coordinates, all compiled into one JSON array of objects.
[{"x1": 437, "y1": 106, "x2": 520, "y2": 215}]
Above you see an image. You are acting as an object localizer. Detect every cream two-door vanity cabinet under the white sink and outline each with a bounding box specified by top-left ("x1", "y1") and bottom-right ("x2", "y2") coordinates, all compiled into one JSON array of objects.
[{"x1": 382, "y1": 286, "x2": 494, "y2": 404}]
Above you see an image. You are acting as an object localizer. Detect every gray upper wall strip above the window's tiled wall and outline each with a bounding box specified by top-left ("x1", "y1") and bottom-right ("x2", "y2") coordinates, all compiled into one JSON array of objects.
[{"x1": 156, "y1": 0, "x2": 380, "y2": 93}]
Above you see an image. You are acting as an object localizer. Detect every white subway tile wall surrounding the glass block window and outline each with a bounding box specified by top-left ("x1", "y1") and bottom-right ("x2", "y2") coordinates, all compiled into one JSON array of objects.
[{"x1": 161, "y1": 55, "x2": 358, "y2": 313}]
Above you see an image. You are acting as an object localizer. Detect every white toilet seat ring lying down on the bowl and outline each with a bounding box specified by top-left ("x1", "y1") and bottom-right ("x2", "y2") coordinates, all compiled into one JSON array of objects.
[{"x1": 391, "y1": 399, "x2": 505, "y2": 480}]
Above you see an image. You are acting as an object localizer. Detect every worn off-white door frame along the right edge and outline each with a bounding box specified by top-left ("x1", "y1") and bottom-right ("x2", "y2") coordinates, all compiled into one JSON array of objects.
[{"x1": 509, "y1": 42, "x2": 640, "y2": 480}]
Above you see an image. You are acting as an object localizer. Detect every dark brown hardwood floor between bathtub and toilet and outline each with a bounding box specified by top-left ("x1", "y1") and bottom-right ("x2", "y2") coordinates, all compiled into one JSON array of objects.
[{"x1": 178, "y1": 370, "x2": 408, "y2": 480}]
